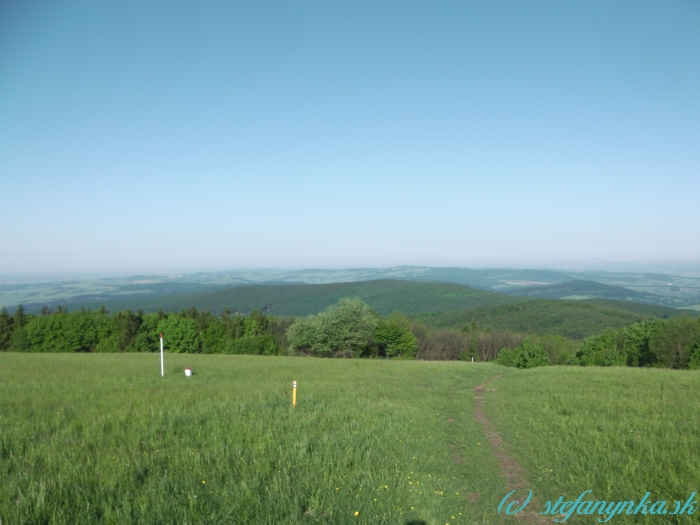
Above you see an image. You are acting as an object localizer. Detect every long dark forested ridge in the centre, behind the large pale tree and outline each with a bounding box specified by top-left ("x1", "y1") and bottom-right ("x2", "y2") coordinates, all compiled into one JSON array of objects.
[{"x1": 86, "y1": 280, "x2": 524, "y2": 316}]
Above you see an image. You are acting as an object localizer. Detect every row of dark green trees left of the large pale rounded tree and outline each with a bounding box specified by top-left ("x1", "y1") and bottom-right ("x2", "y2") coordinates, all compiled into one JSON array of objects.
[{"x1": 0, "y1": 306, "x2": 291, "y2": 355}]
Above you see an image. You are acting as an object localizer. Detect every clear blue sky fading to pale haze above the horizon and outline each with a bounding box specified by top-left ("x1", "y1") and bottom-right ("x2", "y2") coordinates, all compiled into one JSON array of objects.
[{"x1": 0, "y1": 0, "x2": 700, "y2": 273}]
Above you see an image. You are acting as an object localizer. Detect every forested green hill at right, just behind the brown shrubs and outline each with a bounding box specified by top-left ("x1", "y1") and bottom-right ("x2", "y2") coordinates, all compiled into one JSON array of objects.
[{"x1": 415, "y1": 299, "x2": 694, "y2": 338}]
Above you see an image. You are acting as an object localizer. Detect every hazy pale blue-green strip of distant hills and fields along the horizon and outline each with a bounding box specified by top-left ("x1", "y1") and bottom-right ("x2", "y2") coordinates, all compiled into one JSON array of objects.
[{"x1": 6, "y1": 266, "x2": 700, "y2": 311}]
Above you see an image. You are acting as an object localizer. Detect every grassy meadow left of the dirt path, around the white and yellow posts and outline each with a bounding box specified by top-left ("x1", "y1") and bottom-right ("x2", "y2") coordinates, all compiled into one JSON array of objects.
[{"x1": 0, "y1": 354, "x2": 506, "y2": 525}]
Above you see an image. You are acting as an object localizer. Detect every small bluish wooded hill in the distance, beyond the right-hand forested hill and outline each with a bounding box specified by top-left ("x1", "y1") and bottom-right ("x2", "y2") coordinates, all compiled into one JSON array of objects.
[{"x1": 505, "y1": 281, "x2": 657, "y2": 304}]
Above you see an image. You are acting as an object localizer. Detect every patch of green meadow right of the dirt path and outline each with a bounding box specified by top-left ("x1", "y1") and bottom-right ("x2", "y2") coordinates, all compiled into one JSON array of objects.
[{"x1": 484, "y1": 367, "x2": 700, "y2": 524}]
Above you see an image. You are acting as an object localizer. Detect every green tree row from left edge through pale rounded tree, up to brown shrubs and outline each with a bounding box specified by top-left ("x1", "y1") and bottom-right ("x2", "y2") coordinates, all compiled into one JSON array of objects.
[{"x1": 0, "y1": 299, "x2": 416, "y2": 358}]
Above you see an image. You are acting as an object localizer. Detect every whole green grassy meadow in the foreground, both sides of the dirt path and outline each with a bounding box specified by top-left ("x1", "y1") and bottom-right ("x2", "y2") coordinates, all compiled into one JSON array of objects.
[{"x1": 0, "y1": 353, "x2": 700, "y2": 525}]
